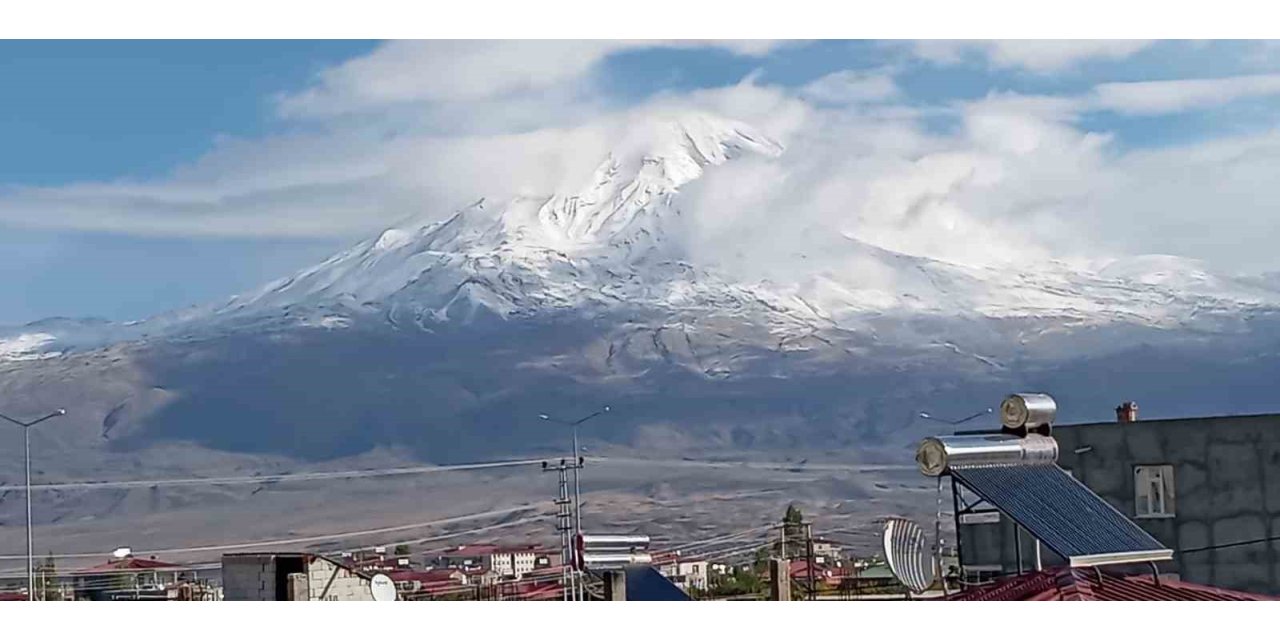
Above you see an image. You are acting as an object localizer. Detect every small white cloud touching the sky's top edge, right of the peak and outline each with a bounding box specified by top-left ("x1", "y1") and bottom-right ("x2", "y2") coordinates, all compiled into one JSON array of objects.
[{"x1": 914, "y1": 40, "x2": 1152, "y2": 73}]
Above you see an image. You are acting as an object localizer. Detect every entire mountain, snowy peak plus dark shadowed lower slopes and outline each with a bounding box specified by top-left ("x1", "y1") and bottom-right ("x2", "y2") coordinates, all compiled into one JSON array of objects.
[{"x1": 0, "y1": 114, "x2": 1280, "y2": 460}]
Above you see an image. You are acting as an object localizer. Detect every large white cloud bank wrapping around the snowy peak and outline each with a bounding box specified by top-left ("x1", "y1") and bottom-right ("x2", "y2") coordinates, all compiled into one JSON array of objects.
[{"x1": 0, "y1": 42, "x2": 1280, "y2": 278}]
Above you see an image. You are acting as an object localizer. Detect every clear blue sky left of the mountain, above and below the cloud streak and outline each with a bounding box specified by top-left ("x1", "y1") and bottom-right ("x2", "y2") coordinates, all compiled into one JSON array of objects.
[{"x1": 0, "y1": 41, "x2": 376, "y2": 324}]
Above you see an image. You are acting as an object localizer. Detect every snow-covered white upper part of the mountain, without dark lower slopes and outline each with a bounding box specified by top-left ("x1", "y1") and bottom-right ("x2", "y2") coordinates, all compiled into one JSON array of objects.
[{"x1": 12, "y1": 114, "x2": 1280, "y2": 360}]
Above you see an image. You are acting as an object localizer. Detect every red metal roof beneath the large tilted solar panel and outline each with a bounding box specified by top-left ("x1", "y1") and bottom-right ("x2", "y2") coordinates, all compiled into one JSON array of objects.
[{"x1": 945, "y1": 567, "x2": 1277, "y2": 602}]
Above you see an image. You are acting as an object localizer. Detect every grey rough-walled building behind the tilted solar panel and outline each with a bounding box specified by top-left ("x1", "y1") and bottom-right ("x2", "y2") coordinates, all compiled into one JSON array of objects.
[{"x1": 959, "y1": 403, "x2": 1280, "y2": 594}]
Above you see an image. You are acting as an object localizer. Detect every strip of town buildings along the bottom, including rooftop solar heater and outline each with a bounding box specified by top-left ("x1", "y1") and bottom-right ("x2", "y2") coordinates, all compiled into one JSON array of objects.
[{"x1": 0, "y1": 393, "x2": 1280, "y2": 600}]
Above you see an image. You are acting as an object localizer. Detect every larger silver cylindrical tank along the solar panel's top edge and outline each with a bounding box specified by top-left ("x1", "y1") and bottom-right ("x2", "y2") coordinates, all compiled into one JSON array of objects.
[{"x1": 915, "y1": 434, "x2": 1057, "y2": 476}]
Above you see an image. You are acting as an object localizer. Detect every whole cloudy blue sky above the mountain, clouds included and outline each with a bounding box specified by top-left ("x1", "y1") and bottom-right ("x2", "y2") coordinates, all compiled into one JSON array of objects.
[{"x1": 0, "y1": 41, "x2": 1280, "y2": 325}]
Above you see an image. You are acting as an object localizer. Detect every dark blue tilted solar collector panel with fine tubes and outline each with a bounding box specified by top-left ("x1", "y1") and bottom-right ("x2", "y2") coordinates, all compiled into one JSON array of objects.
[{"x1": 951, "y1": 465, "x2": 1165, "y2": 558}]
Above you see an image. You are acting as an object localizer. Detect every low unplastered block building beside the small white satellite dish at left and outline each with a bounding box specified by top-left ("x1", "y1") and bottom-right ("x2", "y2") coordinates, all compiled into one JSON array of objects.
[{"x1": 223, "y1": 553, "x2": 374, "y2": 600}]
